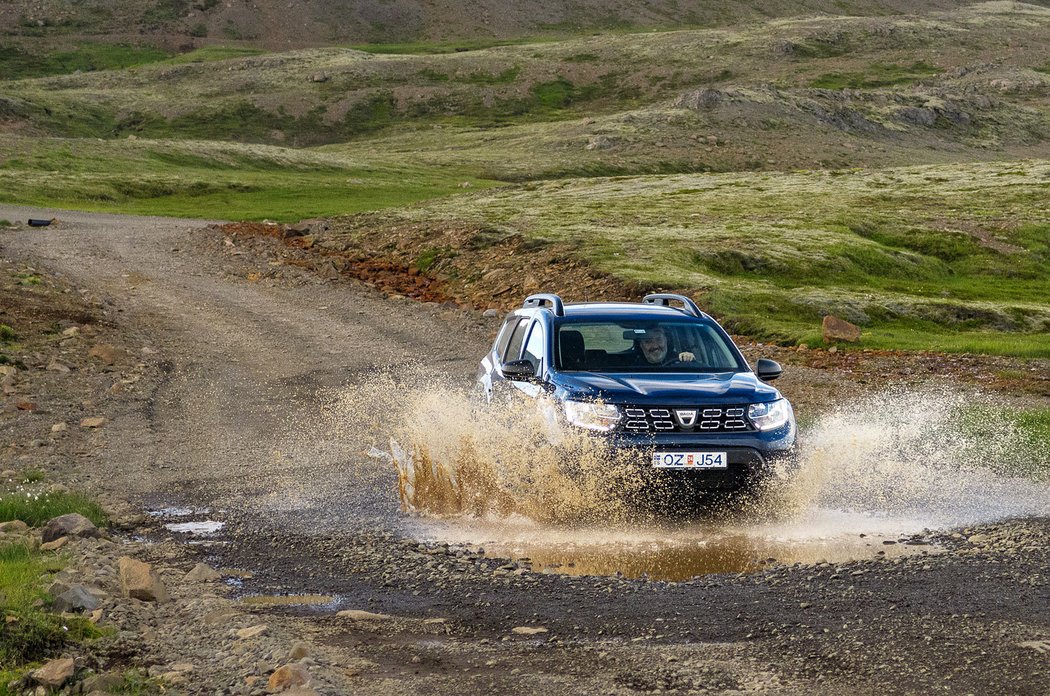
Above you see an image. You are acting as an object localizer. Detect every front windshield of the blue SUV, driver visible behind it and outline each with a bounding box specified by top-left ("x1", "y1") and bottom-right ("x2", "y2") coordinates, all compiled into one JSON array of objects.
[{"x1": 555, "y1": 319, "x2": 747, "y2": 373}]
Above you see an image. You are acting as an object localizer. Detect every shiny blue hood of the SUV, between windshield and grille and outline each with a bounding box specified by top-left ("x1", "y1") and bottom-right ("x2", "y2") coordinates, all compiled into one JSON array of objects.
[{"x1": 557, "y1": 373, "x2": 780, "y2": 406}]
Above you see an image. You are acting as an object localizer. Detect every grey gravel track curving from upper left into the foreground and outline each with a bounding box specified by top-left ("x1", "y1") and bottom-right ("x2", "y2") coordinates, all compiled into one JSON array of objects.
[{"x1": 0, "y1": 207, "x2": 1050, "y2": 694}]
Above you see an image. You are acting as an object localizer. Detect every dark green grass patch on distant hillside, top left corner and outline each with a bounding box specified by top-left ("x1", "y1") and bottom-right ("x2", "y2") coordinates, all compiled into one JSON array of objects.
[{"x1": 0, "y1": 42, "x2": 170, "y2": 80}]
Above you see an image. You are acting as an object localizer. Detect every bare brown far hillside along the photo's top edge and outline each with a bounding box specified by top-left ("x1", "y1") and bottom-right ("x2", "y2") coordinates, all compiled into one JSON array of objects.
[{"x1": 0, "y1": 0, "x2": 991, "y2": 49}]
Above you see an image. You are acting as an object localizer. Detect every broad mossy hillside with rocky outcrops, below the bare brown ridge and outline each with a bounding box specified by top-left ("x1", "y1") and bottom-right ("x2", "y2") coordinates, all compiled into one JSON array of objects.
[{"x1": 6, "y1": 3, "x2": 1050, "y2": 151}]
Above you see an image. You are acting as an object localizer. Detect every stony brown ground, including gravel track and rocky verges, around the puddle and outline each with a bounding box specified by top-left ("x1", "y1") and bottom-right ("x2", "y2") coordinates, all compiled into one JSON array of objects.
[{"x1": 0, "y1": 208, "x2": 1050, "y2": 694}]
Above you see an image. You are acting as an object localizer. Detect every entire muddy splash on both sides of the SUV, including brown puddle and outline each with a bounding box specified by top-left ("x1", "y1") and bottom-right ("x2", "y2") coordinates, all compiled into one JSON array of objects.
[{"x1": 335, "y1": 374, "x2": 1050, "y2": 579}]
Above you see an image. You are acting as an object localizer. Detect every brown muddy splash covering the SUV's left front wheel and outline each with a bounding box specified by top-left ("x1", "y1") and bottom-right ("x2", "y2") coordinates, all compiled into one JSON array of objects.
[{"x1": 333, "y1": 373, "x2": 663, "y2": 524}]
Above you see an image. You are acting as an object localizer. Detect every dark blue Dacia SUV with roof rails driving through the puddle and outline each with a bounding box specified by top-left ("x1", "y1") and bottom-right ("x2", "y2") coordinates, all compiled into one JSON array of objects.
[{"x1": 478, "y1": 294, "x2": 796, "y2": 490}]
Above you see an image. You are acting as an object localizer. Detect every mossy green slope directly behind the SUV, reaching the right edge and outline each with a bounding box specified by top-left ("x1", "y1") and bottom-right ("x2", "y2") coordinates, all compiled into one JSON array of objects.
[{"x1": 345, "y1": 161, "x2": 1050, "y2": 357}]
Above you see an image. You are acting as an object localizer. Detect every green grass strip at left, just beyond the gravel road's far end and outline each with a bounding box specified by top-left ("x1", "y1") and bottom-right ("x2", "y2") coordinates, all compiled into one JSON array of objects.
[{"x1": 0, "y1": 140, "x2": 490, "y2": 222}]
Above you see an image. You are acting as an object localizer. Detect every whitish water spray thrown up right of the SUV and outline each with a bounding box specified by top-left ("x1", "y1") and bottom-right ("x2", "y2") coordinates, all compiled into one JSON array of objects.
[{"x1": 767, "y1": 391, "x2": 1050, "y2": 528}]
